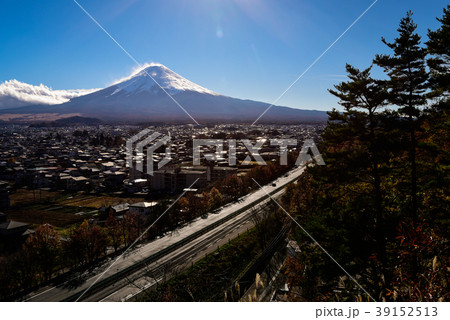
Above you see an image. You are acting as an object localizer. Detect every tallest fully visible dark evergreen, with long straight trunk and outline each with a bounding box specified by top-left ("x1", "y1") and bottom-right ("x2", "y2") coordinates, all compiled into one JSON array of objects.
[{"x1": 374, "y1": 11, "x2": 428, "y2": 220}]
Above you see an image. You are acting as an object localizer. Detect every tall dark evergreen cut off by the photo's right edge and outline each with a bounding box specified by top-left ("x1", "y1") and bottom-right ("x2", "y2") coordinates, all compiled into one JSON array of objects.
[{"x1": 422, "y1": 5, "x2": 450, "y2": 237}]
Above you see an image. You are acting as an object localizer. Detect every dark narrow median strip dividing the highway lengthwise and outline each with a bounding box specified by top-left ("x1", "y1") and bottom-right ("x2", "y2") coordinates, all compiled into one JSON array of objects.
[{"x1": 62, "y1": 168, "x2": 304, "y2": 301}]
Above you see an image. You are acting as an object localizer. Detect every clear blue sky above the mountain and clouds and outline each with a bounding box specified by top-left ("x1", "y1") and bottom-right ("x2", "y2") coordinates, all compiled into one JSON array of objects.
[{"x1": 0, "y1": 0, "x2": 448, "y2": 110}]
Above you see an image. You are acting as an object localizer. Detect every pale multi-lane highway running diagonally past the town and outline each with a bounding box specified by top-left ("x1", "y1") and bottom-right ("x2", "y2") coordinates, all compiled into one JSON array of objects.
[{"x1": 24, "y1": 166, "x2": 305, "y2": 301}]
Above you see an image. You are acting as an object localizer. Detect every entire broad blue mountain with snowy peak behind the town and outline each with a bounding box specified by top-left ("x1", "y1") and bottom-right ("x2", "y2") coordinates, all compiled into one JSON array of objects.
[{"x1": 0, "y1": 63, "x2": 327, "y2": 122}]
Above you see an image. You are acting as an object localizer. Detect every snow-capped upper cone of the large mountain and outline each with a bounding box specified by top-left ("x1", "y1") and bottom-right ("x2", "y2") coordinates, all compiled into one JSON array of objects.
[{"x1": 111, "y1": 63, "x2": 218, "y2": 96}]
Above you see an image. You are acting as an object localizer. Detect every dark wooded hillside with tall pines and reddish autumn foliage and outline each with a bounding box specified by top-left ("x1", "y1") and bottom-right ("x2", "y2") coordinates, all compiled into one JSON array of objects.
[{"x1": 284, "y1": 6, "x2": 450, "y2": 301}]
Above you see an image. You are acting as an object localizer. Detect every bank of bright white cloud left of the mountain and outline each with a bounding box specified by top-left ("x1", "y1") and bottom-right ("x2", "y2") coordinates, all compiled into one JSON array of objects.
[{"x1": 0, "y1": 80, "x2": 99, "y2": 109}]
